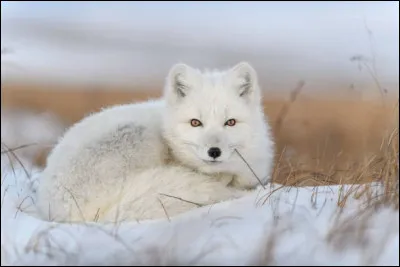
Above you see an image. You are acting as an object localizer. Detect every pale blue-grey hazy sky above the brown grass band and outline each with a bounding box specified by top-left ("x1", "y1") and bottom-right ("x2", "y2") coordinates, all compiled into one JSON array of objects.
[{"x1": 1, "y1": 1, "x2": 399, "y2": 94}]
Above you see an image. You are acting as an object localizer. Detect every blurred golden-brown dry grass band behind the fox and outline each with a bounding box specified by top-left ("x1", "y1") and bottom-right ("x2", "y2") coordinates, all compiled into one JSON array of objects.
[{"x1": 1, "y1": 83, "x2": 398, "y2": 185}]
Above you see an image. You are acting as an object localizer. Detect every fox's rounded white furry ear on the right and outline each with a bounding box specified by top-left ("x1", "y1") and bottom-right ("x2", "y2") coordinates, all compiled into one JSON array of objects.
[{"x1": 231, "y1": 62, "x2": 260, "y2": 101}]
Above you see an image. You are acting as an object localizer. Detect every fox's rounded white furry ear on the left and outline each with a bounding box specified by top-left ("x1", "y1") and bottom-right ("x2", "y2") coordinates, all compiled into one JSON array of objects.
[{"x1": 165, "y1": 63, "x2": 193, "y2": 100}]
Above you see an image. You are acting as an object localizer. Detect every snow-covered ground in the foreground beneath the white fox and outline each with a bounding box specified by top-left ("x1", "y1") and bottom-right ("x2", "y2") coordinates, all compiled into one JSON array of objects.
[{"x1": 1, "y1": 165, "x2": 399, "y2": 266}]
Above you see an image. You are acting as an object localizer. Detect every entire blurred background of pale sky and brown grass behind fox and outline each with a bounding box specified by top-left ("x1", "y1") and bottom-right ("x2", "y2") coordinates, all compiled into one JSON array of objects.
[{"x1": 1, "y1": 1, "x2": 399, "y2": 184}]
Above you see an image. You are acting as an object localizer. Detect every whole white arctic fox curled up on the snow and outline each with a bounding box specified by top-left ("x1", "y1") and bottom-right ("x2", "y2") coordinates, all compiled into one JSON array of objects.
[{"x1": 37, "y1": 62, "x2": 274, "y2": 222}]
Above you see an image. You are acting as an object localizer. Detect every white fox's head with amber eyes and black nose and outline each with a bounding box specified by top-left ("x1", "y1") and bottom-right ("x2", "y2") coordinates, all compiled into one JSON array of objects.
[{"x1": 163, "y1": 62, "x2": 265, "y2": 182}]
